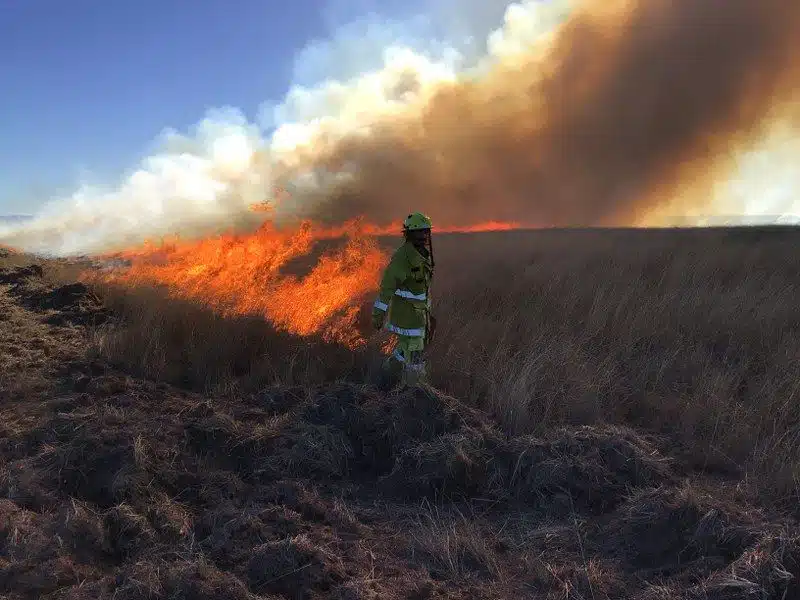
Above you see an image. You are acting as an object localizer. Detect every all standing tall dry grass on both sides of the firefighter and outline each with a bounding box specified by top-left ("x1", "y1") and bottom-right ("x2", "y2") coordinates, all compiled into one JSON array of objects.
[{"x1": 87, "y1": 230, "x2": 800, "y2": 501}]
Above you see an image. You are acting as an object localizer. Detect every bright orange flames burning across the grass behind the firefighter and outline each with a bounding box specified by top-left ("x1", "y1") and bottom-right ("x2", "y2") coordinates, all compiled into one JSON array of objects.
[{"x1": 95, "y1": 221, "x2": 516, "y2": 348}]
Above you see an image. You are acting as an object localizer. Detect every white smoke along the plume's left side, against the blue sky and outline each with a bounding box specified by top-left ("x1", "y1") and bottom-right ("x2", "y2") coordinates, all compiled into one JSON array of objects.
[{"x1": 0, "y1": 0, "x2": 570, "y2": 255}]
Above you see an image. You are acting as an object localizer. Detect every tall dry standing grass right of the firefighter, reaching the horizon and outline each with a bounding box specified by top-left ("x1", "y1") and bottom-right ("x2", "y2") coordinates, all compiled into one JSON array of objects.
[{"x1": 435, "y1": 230, "x2": 800, "y2": 506}]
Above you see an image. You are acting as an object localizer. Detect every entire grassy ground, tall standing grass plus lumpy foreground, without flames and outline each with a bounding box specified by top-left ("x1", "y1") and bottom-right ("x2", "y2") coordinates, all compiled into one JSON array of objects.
[{"x1": 0, "y1": 229, "x2": 800, "y2": 600}]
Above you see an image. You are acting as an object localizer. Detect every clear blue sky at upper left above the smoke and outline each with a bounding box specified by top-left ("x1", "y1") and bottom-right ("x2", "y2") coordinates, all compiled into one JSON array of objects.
[{"x1": 0, "y1": 0, "x2": 400, "y2": 214}]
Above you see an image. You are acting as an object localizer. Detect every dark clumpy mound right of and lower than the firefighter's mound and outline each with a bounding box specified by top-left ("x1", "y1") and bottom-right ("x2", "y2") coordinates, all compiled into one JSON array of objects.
[{"x1": 384, "y1": 420, "x2": 670, "y2": 514}]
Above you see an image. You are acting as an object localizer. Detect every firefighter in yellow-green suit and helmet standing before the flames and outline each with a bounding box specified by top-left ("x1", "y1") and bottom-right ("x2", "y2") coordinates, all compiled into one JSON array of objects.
[{"x1": 372, "y1": 212, "x2": 436, "y2": 385}]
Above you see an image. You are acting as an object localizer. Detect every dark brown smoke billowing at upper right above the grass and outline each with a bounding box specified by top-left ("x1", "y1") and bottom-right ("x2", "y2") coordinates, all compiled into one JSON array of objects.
[{"x1": 304, "y1": 0, "x2": 800, "y2": 226}]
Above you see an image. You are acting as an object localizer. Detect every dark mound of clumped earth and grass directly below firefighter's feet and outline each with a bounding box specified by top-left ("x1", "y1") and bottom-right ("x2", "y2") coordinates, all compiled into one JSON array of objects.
[{"x1": 186, "y1": 384, "x2": 488, "y2": 481}]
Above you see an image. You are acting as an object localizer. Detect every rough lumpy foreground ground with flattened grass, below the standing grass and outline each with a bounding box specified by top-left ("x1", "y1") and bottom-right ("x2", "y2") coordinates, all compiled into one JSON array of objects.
[{"x1": 0, "y1": 258, "x2": 800, "y2": 600}]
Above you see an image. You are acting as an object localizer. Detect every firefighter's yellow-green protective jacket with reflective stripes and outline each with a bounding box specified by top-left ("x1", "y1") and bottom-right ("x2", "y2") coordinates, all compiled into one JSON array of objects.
[{"x1": 373, "y1": 242, "x2": 433, "y2": 337}]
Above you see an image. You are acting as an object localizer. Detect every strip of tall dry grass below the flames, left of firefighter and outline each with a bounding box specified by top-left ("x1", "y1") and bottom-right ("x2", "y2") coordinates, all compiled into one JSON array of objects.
[{"x1": 92, "y1": 285, "x2": 376, "y2": 394}]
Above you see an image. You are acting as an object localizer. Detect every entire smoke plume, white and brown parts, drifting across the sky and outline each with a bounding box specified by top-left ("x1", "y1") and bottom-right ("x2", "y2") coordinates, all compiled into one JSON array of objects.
[{"x1": 0, "y1": 0, "x2": 800, "y2": 254}]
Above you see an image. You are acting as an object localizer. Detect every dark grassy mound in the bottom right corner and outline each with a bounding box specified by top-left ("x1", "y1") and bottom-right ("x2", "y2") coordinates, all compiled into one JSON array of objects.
[{"x1": 593, "y1": 485, "x2": 800, "y2": 599}]
